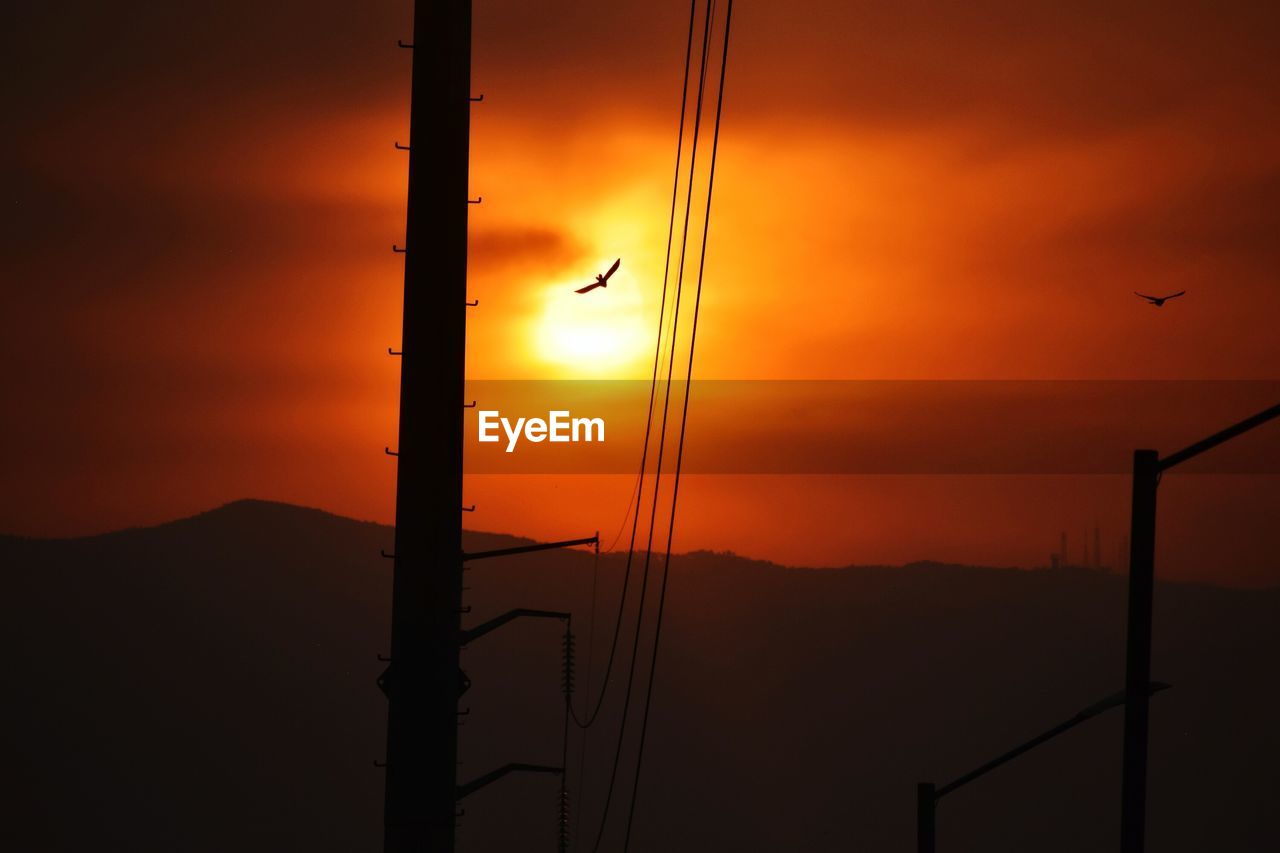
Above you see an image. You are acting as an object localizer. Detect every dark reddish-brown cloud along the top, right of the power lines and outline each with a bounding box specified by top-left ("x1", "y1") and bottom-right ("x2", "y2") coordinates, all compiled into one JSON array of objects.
[{"x1": 733, "y1": 0, "x2": 1280, "y2": 133}]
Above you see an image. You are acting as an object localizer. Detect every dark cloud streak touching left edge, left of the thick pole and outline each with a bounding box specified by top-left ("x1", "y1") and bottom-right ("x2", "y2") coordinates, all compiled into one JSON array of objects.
[{"x1": 0, "y1": 173, "x2": 402, "y2": 305}]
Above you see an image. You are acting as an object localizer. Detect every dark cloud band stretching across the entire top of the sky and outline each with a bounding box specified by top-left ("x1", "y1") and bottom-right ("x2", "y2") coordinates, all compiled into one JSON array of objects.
[{"x1": 10, "y1": 0, "x2": 1280, "y2": 161}]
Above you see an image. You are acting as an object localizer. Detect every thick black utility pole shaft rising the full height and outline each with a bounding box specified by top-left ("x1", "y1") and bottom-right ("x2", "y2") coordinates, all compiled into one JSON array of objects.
[{"x1": 379, "y1": 0, "x2": 471, "y2": 853}]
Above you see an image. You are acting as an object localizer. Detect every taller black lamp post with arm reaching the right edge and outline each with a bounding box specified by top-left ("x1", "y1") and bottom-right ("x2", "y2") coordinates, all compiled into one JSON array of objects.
[{"x1": 1120, "y1": 403, "x2": 1280, "y2": 853}]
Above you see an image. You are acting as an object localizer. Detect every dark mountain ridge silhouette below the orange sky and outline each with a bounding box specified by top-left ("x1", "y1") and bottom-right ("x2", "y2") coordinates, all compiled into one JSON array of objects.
[{"x1": 0, "y1": 501, "x2": 1280, "y2": 853}]
